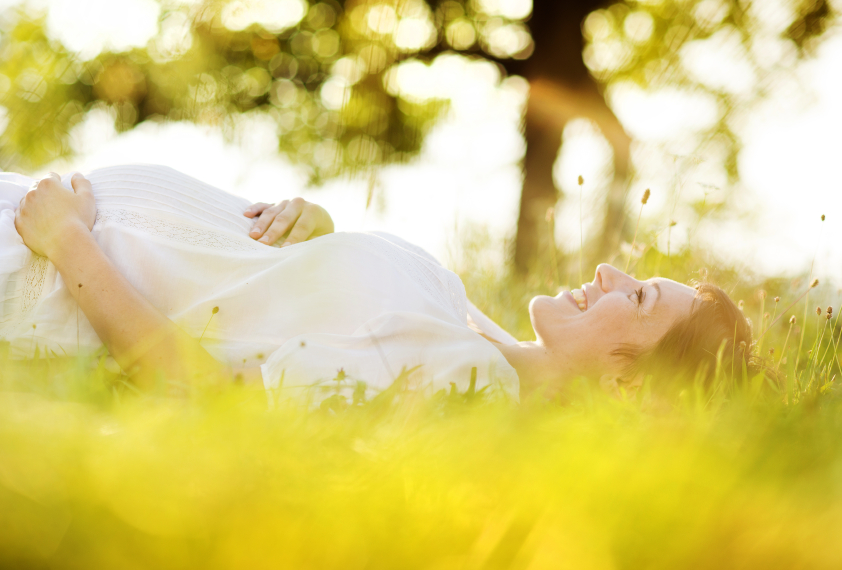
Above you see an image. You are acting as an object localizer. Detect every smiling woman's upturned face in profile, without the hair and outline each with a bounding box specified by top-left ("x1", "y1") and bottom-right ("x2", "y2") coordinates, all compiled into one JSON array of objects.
[{"x1": 529, "y1": 264, "x2": 696, "y2": 384}]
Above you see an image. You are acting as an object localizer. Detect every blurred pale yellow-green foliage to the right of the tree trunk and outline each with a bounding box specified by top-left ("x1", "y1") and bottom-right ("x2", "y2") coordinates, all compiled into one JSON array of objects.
[{"x1": 582, "y1": 0, "x2": 837, "y2": 181}]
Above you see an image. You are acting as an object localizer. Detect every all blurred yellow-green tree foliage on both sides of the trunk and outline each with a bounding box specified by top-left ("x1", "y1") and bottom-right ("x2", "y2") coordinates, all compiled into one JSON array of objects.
[{"x1": 0, "y1": 0, "x2": 835, "y2": 183}]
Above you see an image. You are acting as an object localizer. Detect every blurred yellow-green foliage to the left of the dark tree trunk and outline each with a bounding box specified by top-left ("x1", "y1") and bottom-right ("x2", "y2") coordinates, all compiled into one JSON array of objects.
[{"x1": 0, "y1": 0, "x2": 531, "y2": 177}]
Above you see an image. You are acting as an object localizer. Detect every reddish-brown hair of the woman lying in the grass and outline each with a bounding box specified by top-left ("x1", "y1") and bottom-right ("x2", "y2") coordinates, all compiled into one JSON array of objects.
[{"x1": 613, "y1": 283, "x2": 777, "y2": 391}]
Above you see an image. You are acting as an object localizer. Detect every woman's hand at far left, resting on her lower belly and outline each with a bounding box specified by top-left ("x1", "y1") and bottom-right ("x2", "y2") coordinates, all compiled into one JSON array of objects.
[{"x1": 15, "y1": 172, "x2": 96, "y2": 261}]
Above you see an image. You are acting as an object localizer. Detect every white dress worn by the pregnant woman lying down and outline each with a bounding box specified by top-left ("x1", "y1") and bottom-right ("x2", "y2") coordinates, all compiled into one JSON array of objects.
[{"x1": 0, "y1": 165, "x2": 518, "y2": 399}]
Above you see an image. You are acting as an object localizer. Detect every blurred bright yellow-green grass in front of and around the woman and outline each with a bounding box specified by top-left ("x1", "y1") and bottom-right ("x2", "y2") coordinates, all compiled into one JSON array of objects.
[{"x1": 0, "y1": 241, "x2": 842, "y2": 569}]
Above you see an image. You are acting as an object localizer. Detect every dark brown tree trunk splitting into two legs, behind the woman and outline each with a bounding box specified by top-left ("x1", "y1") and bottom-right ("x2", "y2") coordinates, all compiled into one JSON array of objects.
[{"x1": 503, "y1": 0, "x2": 631, "y2": 273}]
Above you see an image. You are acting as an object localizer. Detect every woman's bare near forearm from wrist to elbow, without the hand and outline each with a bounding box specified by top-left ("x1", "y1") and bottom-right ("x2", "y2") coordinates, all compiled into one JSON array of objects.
[{"x1": 49, "y1": 227, "x2": 227, "y2": 386}]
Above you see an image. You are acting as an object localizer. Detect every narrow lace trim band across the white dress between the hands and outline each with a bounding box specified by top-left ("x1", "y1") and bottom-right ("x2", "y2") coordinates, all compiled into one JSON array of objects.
[{"x1": 94, "y1": 208, "x2": 266, "y2": 251}]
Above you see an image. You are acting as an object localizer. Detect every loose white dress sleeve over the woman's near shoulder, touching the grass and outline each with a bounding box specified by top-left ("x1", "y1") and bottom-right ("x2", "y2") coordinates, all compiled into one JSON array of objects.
[{"x1": 261, "y1": 312, "x2": 519, "y2": 405}]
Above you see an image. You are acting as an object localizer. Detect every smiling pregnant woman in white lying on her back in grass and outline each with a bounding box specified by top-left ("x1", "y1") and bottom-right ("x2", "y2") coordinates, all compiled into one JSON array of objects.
[{"x1": 0, "y1": 165, "x2": 751, "y2": 399}]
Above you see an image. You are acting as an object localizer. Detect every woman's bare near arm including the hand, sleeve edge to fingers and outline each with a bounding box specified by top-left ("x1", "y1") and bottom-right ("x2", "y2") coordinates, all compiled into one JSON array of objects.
[{"x1": 15, "y1": 175, "x2": 230, "y2": 387}]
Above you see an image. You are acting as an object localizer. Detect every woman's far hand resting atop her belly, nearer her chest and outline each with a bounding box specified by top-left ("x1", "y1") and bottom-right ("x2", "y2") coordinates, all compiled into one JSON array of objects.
[{"x1": 244, "y1": 198, "x2": 333, "y2": 247}]
